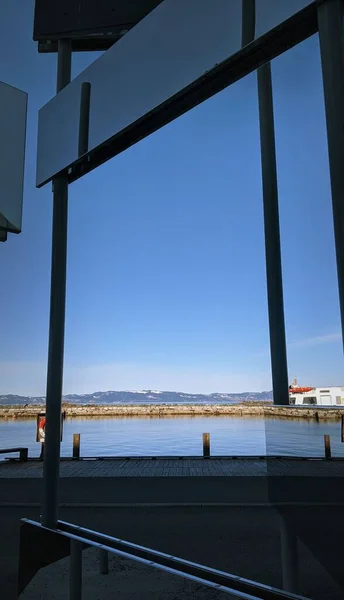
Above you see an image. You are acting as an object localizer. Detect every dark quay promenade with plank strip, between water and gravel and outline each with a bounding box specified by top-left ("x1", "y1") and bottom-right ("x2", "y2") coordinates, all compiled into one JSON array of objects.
[{"x1": 0, "y1": 457, "x2": 344, "y2": 505}]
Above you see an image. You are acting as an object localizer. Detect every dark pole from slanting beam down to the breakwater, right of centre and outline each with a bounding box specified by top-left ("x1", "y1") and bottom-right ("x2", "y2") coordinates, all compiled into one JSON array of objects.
[{"x1": 257, "y1": 63, "x2": 289, "y2": 405}]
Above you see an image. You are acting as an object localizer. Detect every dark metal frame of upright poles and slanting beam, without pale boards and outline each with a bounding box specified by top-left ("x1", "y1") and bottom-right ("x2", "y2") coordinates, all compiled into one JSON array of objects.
[{"x1": 37, "y1": 0, "x2": 344, "y2": 540}]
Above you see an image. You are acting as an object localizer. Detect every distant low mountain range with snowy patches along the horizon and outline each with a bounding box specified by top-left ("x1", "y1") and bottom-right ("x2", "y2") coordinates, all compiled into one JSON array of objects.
[{"x1": 0, "y1": 390, "x2": 273, "y2": 406}]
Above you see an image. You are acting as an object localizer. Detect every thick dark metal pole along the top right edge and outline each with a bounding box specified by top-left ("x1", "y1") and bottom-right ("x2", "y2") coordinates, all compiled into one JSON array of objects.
[{"x1": 317, "y1": 0, "x2": 344, "y2": 352}]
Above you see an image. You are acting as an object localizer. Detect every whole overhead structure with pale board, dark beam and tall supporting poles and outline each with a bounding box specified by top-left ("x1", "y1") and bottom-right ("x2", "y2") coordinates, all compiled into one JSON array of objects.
[{"x1": 35, "y1": 0, "x2": 344, "y2": 527}]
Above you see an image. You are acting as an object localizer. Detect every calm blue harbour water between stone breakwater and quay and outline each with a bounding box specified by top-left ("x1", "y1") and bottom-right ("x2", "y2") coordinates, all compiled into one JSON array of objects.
[{"x1": 0, "y1": 417, "x2": 344, "y2": 459}]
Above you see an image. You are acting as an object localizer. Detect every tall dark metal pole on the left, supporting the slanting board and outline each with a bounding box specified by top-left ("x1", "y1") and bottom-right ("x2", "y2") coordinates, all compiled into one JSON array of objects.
[{"x1": 42, "y1": 40, "x2": 72, "y2": 528}]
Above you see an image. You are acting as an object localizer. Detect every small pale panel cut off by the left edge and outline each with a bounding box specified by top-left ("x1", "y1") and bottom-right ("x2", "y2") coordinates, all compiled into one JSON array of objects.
[{"x1": 0, "y1": 82, "x2": 27, "y2": 233}]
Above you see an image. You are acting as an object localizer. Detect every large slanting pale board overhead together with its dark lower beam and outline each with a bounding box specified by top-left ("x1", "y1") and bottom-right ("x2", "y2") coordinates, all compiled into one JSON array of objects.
[{"x1": 37, "y1": 0, "x2": 316, "y2": 186}]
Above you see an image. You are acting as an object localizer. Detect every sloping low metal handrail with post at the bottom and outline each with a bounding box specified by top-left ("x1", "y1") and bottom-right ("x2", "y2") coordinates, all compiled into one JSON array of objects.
[{"x1": 22, "y1": 519, "x2": 309, "y2": 600}]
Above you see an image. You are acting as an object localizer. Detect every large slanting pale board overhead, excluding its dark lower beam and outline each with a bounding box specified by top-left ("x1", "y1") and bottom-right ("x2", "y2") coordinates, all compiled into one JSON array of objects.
[{"x1": 36, "y1": 0, "x2": 310, "y2": 187}]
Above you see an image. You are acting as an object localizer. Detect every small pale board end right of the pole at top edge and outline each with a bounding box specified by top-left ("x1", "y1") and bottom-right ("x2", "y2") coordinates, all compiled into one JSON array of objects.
[{"x1": 256, "y1": 0, "x2": 314, "y2": 38}]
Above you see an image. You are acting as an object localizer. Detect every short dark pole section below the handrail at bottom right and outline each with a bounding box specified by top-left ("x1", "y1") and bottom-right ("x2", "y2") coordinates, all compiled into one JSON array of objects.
[{"x1": 280, "y1": 516, "x2": 298, "y2": 594}]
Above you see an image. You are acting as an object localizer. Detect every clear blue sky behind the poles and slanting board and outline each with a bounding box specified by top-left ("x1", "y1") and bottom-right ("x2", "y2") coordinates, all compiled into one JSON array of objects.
[{"x1": 0, "y1": 0, "x2": 344, "y2": 395}]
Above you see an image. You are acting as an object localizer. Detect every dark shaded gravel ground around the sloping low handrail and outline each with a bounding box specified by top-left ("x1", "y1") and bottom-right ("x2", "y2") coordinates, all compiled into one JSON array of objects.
[{"x1": 0, "y1": 507, "x2": 343, "y2": 600}]
